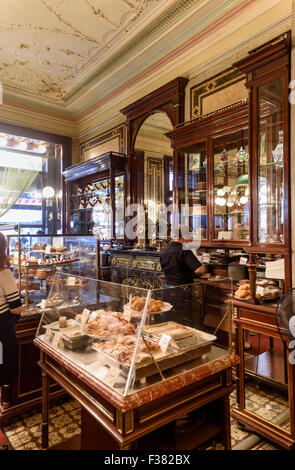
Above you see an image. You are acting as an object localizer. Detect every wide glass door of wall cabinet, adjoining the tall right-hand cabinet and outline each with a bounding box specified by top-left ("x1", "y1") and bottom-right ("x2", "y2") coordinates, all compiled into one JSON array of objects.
[{"x1": 212, "y1": 129, "x2": 249, "y2": 244}]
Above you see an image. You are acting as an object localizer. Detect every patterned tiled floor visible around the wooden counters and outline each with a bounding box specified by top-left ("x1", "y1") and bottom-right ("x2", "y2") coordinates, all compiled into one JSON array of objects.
[{"x1": 3, "y1": 383, "x2": 288, "y2": 450}]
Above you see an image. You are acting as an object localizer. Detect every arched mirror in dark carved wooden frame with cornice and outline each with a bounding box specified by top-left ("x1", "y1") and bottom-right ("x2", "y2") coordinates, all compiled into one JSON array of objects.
[{"x1": 121, "y1": 77, "x2": 188, "y2": 246}]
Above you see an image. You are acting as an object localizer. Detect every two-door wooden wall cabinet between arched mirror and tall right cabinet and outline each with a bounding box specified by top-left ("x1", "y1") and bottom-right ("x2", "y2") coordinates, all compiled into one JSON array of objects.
[{"x1": 167, "y1": 102, "x2": 249, "y2": 248}]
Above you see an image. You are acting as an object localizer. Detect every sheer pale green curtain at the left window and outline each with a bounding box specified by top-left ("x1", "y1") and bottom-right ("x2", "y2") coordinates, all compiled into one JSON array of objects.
[{"x1": 0, "y1": 167, "x2": 39, "y2": 219}]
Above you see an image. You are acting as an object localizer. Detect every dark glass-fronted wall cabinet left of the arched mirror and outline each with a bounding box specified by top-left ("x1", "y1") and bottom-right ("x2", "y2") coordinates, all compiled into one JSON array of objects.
[{"x1": 63, "y1": 152, "x2": 125, "y2": 240}]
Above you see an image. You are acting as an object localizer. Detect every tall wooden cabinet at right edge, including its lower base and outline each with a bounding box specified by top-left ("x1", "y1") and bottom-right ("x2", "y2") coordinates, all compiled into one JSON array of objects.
[{"x1": 233, "y1": 33, "x2": 295, "y2": 449}]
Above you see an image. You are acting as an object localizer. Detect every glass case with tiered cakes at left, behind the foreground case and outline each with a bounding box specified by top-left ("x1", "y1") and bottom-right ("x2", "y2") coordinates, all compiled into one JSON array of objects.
[{"x1": 7, "y1": 235, "x2": 99, "y2": 312}]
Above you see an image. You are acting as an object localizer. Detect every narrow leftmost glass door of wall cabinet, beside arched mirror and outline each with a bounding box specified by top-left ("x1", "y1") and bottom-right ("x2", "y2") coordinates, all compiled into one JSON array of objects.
[{"x1": 179, "y1": 141, "x2": 208, "y2": 240}]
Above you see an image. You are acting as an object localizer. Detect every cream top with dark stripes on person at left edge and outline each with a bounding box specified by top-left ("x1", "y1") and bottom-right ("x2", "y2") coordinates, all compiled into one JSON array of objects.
[{"x1": 0, "y1": 269, "x2": 22, "y2": 315}]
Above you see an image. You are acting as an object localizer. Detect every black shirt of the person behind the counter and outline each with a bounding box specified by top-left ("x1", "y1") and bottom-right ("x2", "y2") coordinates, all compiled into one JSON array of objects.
[{"x1": 160, "y1": 242, "x2": 202, "y2": 286}]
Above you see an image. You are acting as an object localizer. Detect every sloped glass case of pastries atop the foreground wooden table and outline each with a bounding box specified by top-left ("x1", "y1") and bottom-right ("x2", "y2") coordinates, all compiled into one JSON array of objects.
[{"x1": 37, "y1": 272, "x2": 232, "y2": 396}]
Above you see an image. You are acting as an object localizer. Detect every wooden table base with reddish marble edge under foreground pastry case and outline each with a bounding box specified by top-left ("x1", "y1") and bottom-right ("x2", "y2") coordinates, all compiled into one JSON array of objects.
[{"x1": 35, "y1": 338, "x2": 238, "y2": 450}]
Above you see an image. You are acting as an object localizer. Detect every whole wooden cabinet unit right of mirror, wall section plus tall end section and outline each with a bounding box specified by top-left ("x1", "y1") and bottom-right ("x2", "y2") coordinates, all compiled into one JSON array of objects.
[{"x1": 167, "y1": 33, "x2": 295, "y2": 449}]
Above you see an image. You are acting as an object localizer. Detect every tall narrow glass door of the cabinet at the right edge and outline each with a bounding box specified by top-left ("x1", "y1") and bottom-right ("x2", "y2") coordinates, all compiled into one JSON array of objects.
[{"x1": 254, "y1": 77, "x2": 288, "y2": 247}]
